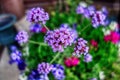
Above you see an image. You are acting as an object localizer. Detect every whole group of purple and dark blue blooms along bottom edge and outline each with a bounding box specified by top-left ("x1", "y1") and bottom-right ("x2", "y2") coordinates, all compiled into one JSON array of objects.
[{"x1": 28, "y1": 62, "x2": 65, "y2": 80}]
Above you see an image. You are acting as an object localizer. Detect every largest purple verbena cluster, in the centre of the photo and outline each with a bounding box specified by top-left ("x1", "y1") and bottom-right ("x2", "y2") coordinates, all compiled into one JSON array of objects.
[{"x1": 45, "y1": 25, "x2": 76, "y2": 52}]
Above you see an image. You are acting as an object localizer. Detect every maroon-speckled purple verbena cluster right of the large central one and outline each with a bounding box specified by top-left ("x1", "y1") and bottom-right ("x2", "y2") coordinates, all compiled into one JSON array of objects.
[{"x1": 74, "y1": 38, "x2": 89, "y2": 56}]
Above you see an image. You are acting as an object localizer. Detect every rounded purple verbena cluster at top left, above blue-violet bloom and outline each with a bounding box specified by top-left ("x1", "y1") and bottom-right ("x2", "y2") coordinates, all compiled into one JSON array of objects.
[{"x1": 27, "y1": 7, "x2": 49, "y2": 24}]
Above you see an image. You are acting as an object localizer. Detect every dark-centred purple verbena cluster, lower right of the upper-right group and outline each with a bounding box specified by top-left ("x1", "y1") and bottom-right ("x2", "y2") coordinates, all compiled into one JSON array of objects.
[{"x1": 92, "y1": 11, "x2": 106, "y2": 28}]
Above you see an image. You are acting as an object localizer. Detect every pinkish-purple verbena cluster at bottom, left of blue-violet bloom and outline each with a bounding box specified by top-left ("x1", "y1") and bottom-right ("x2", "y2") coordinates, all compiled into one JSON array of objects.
[{"x1": 37, "y1": 62, "x2": 52, "y2": 74}]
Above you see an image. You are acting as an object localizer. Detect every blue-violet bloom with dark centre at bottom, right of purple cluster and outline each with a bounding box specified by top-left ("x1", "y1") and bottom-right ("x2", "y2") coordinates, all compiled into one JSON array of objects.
[{"x1": 52, "y1": 64, "x2": 65, "y2": 80}]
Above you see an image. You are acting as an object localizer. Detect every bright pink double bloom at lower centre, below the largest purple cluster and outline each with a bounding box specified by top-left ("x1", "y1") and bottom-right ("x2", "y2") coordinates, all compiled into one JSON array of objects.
[{"x1": 64, "y1": 57, "x2": 80, "y2": 67}]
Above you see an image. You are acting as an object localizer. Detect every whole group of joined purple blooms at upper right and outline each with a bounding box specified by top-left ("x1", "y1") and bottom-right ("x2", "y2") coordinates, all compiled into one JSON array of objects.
[{"x1": 76, "y1": 5, "x2": 108, "y2": 28}]
